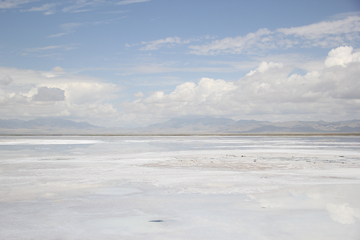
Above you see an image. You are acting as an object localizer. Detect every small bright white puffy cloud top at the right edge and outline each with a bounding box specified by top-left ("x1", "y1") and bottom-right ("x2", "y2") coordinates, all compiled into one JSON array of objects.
[{"x1": 325, "y1": 47, "x2": 360, "y2": 67}]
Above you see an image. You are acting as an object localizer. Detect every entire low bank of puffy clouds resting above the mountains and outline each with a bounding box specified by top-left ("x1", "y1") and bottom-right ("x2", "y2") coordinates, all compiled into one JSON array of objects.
[{"x1": 0, "y1": 46, "x2": 360, "y2": 126}]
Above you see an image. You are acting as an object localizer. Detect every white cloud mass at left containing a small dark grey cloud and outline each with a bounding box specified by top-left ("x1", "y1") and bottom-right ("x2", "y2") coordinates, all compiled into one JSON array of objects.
[{"x1": 0, "y1": 67, "x2": 121, "y2": 124}]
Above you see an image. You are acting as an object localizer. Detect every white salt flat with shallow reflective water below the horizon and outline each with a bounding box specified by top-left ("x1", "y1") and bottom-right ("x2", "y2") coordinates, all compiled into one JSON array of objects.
[{"x1": 0, "y1": 137, "x2": 360, "y2": 239}]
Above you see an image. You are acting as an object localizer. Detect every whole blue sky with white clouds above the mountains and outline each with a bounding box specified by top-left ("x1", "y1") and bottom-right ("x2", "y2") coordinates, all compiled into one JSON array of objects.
[{"x1": 0, "y1": 0, "x2": 360, "y2": 127}]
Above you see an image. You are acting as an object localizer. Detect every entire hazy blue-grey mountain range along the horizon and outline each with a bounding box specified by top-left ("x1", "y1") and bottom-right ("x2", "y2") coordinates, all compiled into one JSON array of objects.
[{"x1": 0, "y1": 117, "x2": 360, "y2": 134}]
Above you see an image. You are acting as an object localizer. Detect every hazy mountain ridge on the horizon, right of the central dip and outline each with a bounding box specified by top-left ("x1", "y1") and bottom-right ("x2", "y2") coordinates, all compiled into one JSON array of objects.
[{"x1": 137, "y1": 117, "x2": 360, "y2": 134}]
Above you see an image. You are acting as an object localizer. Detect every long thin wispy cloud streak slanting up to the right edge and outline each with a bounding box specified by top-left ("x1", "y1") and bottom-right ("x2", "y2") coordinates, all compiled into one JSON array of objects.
[{"x1": 189, "y1": 16, "x2": 360, "y2": 55}]
